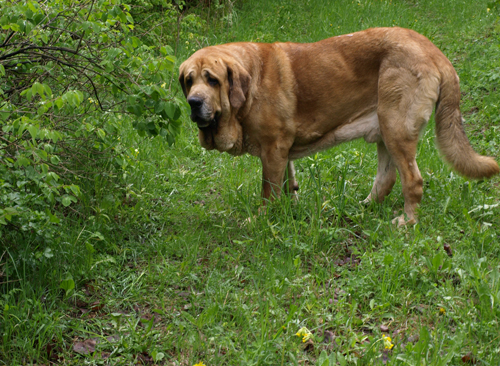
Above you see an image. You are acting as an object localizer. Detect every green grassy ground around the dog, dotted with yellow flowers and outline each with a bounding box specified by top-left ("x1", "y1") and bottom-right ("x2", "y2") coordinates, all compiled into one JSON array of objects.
[{"x1": 0, "y1": 0, "x2": 500, "y2": 366}]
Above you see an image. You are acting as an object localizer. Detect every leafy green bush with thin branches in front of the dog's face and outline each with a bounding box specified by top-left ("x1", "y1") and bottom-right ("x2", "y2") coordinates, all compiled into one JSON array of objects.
[{"x1": 0, "y1": 0, "x2": 181, "y2": 249}]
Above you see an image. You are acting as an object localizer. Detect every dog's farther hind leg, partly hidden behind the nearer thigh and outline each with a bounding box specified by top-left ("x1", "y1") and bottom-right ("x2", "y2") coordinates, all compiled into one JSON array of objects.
[{"x1": 362, "y1": 141, "x2": 396, "y2": 204}]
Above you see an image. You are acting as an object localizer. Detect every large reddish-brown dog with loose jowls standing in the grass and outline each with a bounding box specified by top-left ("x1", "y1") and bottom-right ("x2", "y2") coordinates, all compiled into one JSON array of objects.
[{"x1": 179, "y1": 28, "x2": 499, "y2": 225}]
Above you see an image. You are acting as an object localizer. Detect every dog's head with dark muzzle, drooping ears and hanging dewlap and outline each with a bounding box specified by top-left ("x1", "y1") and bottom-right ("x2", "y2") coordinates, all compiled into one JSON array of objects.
[{"x1": 179, "y1": 46, "x2": 251, "y2": 153}]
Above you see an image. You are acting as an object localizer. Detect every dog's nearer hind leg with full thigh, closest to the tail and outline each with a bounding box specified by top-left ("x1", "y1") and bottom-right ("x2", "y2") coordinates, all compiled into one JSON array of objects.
[{"x1": 377, "y1": 65, "x2": 439, "y2": 226}]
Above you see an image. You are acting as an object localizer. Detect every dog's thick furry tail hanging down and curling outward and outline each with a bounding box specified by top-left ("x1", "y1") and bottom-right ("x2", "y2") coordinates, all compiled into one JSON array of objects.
[{"x1": 436, "y1": 64, "x2": 500, "y2": 179}]
